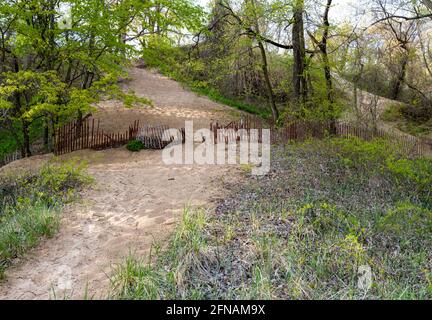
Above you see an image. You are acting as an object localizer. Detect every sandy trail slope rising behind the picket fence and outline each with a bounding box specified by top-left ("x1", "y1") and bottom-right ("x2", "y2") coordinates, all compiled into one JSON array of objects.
[{"x1": 95, "y1": 68, "x2": 240, "y2": 132}]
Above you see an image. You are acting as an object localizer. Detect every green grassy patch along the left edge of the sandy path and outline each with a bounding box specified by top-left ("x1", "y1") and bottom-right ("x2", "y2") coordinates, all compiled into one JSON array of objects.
[{"x1": 0, "y1": 161, "x2": 91, "y2": 278}]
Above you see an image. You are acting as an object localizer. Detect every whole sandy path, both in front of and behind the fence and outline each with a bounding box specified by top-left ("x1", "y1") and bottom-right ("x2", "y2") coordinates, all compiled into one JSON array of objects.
[{"x1": 0, "y1": 69, "x2": 241, "y2": 299}]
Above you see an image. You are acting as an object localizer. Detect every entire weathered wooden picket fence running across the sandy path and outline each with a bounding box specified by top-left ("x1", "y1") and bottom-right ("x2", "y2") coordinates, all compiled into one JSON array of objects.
[{"x1": 41, "y1": 116, "x2": 432, "y2": 155}]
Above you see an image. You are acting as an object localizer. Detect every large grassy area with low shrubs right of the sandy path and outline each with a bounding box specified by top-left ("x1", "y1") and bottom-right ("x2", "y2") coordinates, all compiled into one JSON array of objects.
[{"x1": 108, "y1": 138, "x2": 432, "y2": 299}]
